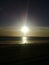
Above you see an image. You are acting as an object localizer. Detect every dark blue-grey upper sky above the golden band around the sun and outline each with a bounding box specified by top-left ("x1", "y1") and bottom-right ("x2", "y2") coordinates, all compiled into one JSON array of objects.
[{"x1": 0, "y1": 0, "x2": 49, "y2": 27}]
